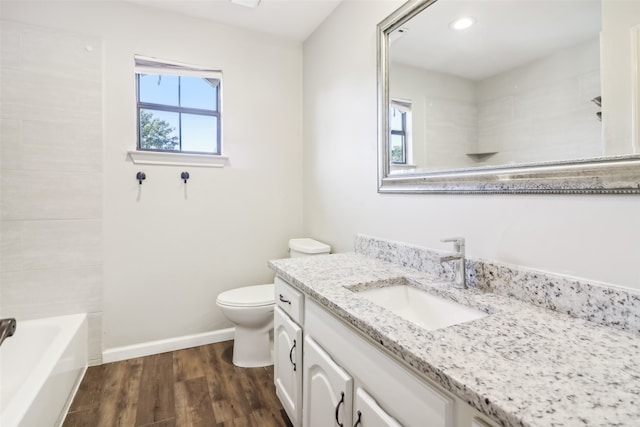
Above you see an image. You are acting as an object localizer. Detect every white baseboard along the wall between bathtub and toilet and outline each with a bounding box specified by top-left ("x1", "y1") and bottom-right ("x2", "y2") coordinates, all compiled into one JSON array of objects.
[{"x1": 102, "y1": 328, "x2": 235, "y2": 363}]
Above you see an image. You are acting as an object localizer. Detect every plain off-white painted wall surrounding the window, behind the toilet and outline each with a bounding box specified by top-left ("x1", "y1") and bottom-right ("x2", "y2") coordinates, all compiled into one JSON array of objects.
[{"x1": 2, "y1": 2, "x2": 302, "y2": 349}]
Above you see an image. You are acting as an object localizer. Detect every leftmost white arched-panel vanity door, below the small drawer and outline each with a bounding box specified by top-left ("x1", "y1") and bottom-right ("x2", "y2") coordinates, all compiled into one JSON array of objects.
[{"x1": 273, "y1": 307, "x2": 302, "y2": 427}]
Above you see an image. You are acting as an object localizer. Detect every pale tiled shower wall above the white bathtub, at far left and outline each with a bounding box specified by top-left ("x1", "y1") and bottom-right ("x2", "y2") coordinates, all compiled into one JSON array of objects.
[{"x1": 0, "y1": 20, "x2": 103, "y2": 363}]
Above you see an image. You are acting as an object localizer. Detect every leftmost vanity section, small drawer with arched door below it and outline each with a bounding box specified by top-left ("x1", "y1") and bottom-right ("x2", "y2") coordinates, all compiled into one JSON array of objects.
[{"x1": 273, "y1": 278, "x2": 304, "y2": 427}]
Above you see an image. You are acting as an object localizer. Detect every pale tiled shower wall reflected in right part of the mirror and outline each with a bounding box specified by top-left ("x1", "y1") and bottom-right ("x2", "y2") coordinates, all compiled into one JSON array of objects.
[{"x1": 477, "y1": 39, "x2": 606, "y2": 164}]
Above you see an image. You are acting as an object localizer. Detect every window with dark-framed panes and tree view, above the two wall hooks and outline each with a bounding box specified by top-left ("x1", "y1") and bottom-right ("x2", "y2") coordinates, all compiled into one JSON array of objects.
[{"x1": 135, "y1": 56, "x2": 222, "y2": 155}]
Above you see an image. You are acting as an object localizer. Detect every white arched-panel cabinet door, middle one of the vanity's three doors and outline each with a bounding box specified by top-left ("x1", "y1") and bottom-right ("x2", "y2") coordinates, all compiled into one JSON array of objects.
[{"x1": 302, "y1": 336, "x2": 353, "y2": 427}]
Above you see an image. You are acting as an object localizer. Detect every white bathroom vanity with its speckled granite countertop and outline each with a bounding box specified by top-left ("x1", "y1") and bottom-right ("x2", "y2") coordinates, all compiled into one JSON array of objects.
[{"x1": 270, "y1": 239, "x2": 640, "y2": 427}]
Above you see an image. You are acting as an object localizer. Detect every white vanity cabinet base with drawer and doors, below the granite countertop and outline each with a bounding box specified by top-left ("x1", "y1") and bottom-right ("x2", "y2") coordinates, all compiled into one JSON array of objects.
[{"x1": 274, "y1": 278, "x2": 495, "y2": 427}]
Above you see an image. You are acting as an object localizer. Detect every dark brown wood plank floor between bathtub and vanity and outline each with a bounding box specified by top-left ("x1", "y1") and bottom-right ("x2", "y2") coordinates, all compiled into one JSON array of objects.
[{"x1": 63, "y1": 341, "x2": 291, "y2": 427}]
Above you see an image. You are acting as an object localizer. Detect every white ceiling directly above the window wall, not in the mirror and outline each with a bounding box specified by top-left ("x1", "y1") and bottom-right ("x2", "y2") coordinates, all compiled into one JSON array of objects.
[{"x1": 129, "y1": 0, "x2": 342, "y2": 41}]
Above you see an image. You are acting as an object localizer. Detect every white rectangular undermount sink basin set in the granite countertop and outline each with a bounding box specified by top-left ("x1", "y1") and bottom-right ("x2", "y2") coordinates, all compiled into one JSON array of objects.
[{"x1": 357, "y1": 285, "x2": 487, "y2": 331}]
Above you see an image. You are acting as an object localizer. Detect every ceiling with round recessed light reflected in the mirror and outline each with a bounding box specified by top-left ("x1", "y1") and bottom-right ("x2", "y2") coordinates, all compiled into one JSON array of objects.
[{"x1": 390, "y1": 0, "x2": 601, "y2": 80}]
